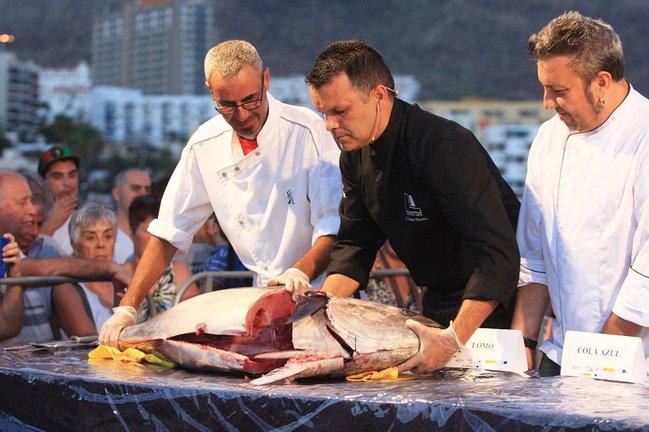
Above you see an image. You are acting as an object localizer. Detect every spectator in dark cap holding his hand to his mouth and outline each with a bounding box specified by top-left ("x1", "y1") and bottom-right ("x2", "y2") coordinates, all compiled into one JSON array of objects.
[{"x1": 38, "y1": 146, "x2": 79, "y2": 255}]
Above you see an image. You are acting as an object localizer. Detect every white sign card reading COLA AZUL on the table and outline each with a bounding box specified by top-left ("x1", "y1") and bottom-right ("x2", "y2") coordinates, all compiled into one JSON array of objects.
[{"x1": 561, "y1": 330, "x2": 647, "y2": 383}]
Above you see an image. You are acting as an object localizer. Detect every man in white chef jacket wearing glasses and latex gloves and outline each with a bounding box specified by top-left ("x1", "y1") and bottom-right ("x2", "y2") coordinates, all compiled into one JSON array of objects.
[{"x1": 100, "y1": 40, "x2": 342, "y2": 347}]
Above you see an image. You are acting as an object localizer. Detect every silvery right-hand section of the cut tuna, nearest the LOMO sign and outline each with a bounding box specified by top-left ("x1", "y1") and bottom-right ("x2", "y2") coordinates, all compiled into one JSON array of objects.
[{"x1": 251, "y1": 297, "x2": 441, "y2": 385}]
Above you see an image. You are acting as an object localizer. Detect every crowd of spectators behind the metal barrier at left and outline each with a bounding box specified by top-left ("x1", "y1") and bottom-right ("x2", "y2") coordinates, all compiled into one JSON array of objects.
[{"x1": 0, "y1": 145, "x2": 239, "y2": 347}]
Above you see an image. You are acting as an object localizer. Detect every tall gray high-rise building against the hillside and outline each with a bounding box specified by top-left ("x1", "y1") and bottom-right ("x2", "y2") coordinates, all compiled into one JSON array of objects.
[{"x1": 92, "y1": 0, "x2": 215, "y2": 95}]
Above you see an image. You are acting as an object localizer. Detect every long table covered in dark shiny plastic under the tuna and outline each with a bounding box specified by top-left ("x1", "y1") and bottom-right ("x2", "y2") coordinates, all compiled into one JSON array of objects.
[{"x1": 0, "y1": 348, "x2": 649, "y2": 432}]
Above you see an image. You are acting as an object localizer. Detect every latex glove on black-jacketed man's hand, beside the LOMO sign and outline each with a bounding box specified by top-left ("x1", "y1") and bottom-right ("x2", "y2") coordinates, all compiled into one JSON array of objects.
[{"x1": 392, "y1": 320, "x2": 464, "y2": 374}]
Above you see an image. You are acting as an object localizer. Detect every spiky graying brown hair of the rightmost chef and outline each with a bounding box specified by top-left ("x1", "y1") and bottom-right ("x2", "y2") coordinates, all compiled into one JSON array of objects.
[{"x1": 527, "y1": 11, "x2": 624, "y2": 85}]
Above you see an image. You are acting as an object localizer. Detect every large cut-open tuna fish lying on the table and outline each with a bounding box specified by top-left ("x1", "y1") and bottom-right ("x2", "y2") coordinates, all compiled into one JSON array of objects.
[{"x1": 119, "y1": 288, "x2": 438, "y2": 384}]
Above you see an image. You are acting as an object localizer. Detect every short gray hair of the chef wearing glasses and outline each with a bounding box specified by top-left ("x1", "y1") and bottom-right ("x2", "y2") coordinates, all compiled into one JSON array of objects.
[{"x1": 205, "y1": 40, "x2": 263, "y2": 81}]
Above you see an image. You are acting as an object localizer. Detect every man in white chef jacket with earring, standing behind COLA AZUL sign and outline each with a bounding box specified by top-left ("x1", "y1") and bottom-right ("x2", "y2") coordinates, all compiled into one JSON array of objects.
[{"x1": 512, "y1": 12, "x2": 649, "y2": 375}]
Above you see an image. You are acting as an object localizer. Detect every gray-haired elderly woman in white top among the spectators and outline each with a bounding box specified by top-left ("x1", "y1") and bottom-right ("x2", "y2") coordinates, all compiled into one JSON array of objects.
[{"x1": 69, "y1": 202, "x2": 117, "y2": 330}]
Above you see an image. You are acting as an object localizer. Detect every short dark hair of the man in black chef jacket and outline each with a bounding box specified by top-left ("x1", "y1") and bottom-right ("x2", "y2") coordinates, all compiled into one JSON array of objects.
[{"x1": 305, "y1": 40, "x2": 394, "y2": 98}]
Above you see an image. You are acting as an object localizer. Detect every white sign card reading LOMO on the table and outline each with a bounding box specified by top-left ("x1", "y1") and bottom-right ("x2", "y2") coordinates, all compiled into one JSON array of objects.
[{"x1": 446, "y1": 328, "x2": 527, "y2": 376}]
